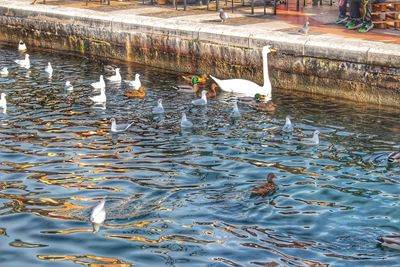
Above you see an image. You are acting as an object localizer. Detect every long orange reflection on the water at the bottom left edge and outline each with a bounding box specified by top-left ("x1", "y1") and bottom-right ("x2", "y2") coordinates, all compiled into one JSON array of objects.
[{"x1": 37, "y1": 255, "x2": 133, "y2": 267}]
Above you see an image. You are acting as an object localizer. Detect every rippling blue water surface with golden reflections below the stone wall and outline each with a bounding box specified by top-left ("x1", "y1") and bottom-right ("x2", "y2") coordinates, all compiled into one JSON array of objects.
[{"x1": 0, "y1": 45, "x2": 400, "y2": 266}]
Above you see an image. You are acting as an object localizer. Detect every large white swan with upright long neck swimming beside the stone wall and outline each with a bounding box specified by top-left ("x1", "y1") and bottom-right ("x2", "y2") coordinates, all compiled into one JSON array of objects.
[{"x1": 210, "y1": 45, "x2": 276, "y2": 99}]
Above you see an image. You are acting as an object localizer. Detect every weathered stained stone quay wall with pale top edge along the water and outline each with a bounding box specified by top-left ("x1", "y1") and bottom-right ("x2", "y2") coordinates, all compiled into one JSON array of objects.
[{"x1": 0, "y1": 5, "x2": 400, "y2": 106}]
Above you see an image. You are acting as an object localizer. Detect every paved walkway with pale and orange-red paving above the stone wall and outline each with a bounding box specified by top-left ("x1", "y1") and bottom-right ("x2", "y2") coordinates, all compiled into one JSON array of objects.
[{"x1": 32, "y1": 0, "x2": 400, "y2": 44}]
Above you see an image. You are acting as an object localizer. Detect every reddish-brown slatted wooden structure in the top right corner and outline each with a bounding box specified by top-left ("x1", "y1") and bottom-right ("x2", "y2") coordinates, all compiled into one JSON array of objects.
[{"x1": 371, "y1": 0, "x2": 400, "y2": 30}]
